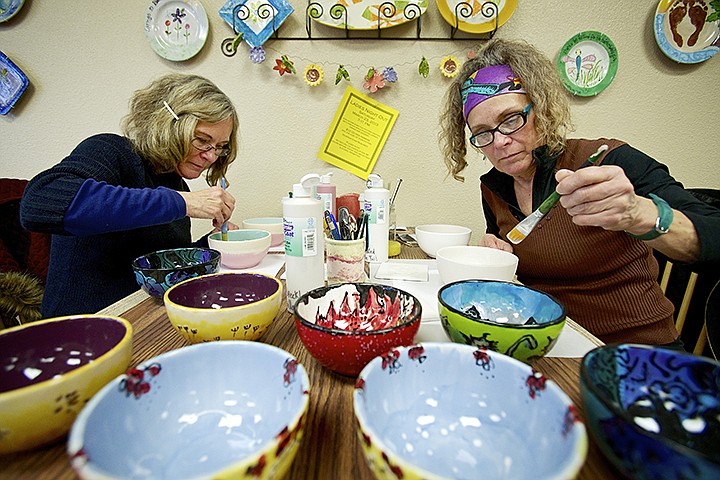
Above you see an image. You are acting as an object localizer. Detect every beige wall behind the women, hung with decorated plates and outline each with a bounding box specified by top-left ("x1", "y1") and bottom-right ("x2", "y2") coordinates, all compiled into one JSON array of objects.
[{"x1": 0, "y1": 0, "x2": 720, "y2": 238}]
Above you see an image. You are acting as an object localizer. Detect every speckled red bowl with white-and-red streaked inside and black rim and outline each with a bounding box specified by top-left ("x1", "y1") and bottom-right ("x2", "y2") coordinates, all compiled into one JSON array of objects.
[{"x1": 295, "y1": 283, "x2": 422, "y2": 377}]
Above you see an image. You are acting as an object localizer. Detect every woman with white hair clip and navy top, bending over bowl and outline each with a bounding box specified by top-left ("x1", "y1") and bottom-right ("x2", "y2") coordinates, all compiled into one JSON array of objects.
[{"x1": 20, "y1": 73, "x2": 238, "y2": 318}]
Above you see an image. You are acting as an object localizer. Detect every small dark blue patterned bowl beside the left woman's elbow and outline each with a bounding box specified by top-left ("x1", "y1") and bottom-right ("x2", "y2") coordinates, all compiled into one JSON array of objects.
[{"x1": 132, "y1": 247, "x2": 220, "y2": 300}]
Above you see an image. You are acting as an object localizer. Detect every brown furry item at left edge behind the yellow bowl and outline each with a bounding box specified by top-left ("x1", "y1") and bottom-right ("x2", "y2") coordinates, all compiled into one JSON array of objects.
[{"x1": 0, "y1": 272, "x2": 44, "y2": 329}]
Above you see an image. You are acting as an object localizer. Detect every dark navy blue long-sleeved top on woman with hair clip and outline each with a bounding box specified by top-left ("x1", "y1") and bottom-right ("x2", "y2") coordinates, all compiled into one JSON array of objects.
[{"x1": 20, "y1": 134, "x2": 198, "y2": 318}]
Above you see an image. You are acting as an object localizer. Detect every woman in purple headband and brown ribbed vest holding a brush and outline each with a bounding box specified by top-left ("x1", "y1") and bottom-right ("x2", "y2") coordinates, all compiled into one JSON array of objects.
[{"x1": 440, "y1": 39, "x2": 720, "y2": 348}]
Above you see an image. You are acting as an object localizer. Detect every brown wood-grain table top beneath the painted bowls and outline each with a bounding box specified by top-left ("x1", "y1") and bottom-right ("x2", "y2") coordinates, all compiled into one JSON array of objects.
[{"x1": 0, "y1": 245, "x2": 617, "y2": 480}]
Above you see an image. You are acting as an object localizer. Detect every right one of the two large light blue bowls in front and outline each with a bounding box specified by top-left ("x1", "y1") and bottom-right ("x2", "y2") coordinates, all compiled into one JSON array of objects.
[{"x1": 354, "y1": 343, "x2": 588, "y2": 480}]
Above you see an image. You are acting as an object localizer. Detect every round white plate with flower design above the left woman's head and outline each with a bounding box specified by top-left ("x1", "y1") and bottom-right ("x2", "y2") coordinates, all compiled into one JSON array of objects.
[{"x1": 142, "y1": 0, "x2": 208, "y2": 62}]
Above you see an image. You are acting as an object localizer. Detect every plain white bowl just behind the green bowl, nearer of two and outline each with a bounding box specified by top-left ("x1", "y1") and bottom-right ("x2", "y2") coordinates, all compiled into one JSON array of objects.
[{"x1": 437, "y1": 245, "x2": 518, "y2": 285}]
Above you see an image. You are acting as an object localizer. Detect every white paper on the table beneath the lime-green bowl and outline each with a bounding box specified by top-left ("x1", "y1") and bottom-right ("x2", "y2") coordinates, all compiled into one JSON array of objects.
[{"x1": 372, "y1": 260, "x2": 597, "y2": 358}]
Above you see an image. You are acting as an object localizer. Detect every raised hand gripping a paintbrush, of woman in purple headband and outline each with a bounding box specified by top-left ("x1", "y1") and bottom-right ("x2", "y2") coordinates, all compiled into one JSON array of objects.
[{"x1": 555, "y1": 165, "x2": 657, "y2": 235}]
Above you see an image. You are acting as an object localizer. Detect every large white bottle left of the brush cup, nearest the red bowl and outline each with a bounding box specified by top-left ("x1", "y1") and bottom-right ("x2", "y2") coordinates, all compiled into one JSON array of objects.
[{"x1": 282, "y1": 173, "x2": 325, "y2": 312}]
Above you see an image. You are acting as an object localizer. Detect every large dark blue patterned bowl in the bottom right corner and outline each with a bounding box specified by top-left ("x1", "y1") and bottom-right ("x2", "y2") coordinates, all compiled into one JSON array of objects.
[{"x1": 580, "y1": 344, "x2": 720, "y2": 480}]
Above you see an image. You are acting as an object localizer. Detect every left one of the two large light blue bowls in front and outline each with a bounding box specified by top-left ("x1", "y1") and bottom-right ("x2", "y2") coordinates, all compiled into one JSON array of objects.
[{"x1": 67, "y1": 340, "x2": 309, "y2": 479}]
